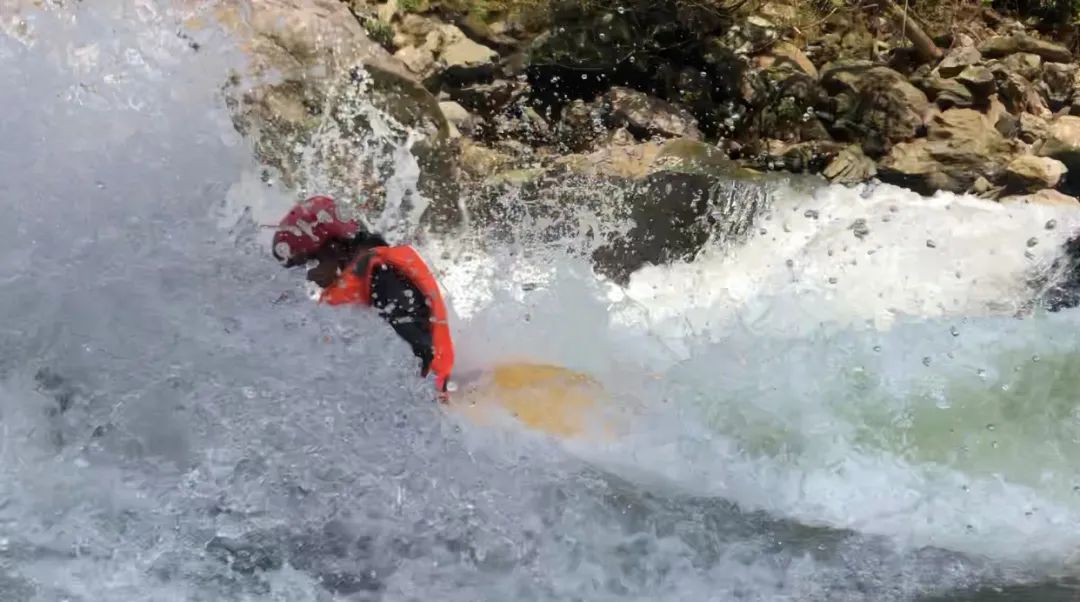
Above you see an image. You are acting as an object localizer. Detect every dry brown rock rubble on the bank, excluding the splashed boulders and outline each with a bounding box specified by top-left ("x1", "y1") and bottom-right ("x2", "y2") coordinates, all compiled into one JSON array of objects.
[{"x1": 350, "y1": 0, "x2": 1080, "y2": 202}]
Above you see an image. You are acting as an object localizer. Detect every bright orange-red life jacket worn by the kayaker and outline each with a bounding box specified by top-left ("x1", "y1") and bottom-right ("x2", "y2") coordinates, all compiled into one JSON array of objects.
[{"x1": 319, "y1": 246, "x2": 454, "y2": 392}]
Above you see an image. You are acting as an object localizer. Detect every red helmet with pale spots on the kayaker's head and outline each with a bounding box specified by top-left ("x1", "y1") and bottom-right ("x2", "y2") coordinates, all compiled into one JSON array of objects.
[{"x1": 273, "y1": 197, "x2": 360, "y2": 266}]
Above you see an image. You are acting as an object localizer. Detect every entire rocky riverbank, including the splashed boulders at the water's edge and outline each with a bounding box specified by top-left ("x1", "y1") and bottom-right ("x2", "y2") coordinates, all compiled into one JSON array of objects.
[{"x1": 185, "y1": 0, "x2": 1080, "y2": 279}]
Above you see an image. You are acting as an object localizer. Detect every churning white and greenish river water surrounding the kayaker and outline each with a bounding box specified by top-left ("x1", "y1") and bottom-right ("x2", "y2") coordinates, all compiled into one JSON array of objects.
[{"x1": 6, "y1": 1, "x2": 1080, "y2": 602}]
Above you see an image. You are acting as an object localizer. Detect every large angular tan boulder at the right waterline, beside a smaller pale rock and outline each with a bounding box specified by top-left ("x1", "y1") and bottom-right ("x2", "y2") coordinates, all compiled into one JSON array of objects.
[{"x1": 878, "y1": 109, "x2": 1016, "y2": 195}]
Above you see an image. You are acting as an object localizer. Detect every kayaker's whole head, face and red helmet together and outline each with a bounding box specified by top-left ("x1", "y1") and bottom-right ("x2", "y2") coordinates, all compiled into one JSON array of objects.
[{"x1": 272, "y1": 197, "x2": 386, "y2": 287}]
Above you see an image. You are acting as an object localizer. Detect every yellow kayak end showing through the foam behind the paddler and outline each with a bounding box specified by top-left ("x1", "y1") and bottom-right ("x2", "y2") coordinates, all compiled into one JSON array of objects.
[{"x1": 449, "y1": 362, "x2": 615, "y2": 439}]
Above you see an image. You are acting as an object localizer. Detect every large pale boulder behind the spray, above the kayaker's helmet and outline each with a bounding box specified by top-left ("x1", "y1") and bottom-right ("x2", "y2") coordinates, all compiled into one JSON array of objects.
[{"x1": 215, "y1": 0, "x2": 460, "y2": 229}]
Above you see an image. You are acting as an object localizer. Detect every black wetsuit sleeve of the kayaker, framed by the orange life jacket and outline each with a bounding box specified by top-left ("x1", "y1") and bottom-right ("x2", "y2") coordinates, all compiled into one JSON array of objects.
[{"x1": 372, "y1": 265, "x2": 434, "y2": 376}]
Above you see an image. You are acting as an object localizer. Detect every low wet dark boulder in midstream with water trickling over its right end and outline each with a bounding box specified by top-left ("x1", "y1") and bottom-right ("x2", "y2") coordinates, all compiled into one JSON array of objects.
[{"x1": 462, "y1": 162, "x2": 769, "y2": 284}]
